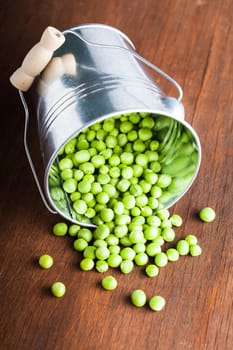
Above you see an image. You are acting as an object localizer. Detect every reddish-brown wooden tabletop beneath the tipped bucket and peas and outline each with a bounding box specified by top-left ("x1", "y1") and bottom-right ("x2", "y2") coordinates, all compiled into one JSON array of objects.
[{"x1": 0, "y1": 0, "x2": 233, "y2": 350}]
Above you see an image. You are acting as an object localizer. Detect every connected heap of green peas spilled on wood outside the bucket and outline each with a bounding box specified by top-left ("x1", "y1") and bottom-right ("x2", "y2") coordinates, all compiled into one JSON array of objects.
[{"x1": 53, "y1": 209, "x2": 201, "y2": 277}]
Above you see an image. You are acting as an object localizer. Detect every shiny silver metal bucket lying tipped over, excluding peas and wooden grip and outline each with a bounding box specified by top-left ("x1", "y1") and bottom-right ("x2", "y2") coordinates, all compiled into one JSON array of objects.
[{"x1": 11, "y1": 24, "x2": 201, "y2": 226}]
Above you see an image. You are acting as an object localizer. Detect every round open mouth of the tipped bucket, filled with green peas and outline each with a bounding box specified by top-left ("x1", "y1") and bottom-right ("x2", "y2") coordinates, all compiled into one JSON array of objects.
[{"x1": 46, "y1": 112, "x2": 200, "y2": 226}]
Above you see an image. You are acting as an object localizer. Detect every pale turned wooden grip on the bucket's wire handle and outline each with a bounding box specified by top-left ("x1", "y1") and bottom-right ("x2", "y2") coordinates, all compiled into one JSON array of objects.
[{"x1": 10, "y1": 27, "x2": 65, "y2": 91}]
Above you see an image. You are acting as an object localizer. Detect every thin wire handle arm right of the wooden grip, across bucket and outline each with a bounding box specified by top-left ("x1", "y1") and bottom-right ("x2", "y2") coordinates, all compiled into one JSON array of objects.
[{"x1": 62, "y1": 29, "x2": 183, "y2": 102}]
